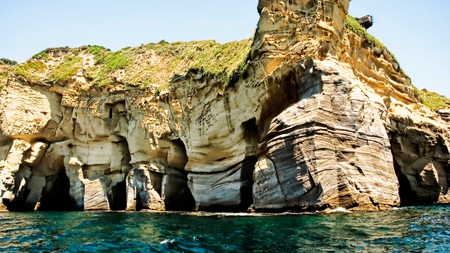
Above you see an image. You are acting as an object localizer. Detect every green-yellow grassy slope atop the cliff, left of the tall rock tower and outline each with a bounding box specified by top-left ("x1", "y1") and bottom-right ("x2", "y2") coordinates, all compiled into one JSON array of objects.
[{"x1": 9, "y1": 40, "x2": 251, "y2": 91}]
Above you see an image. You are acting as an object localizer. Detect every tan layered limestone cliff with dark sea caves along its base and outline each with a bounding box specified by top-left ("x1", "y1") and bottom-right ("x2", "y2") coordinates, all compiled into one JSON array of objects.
[{"x1": 0, "y1": 0, "x2": 450, "y2": 211}]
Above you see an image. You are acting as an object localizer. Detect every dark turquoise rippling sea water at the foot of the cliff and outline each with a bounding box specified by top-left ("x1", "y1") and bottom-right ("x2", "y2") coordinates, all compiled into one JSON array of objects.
[{"x1": 0, "y1": 206, "x2": 450, "y2": 253}]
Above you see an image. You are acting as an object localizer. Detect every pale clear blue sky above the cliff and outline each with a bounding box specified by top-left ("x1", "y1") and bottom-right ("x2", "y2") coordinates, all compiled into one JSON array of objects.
[{"x1": 0, "y1": 0, "x2": 450, "y2": 97}]
